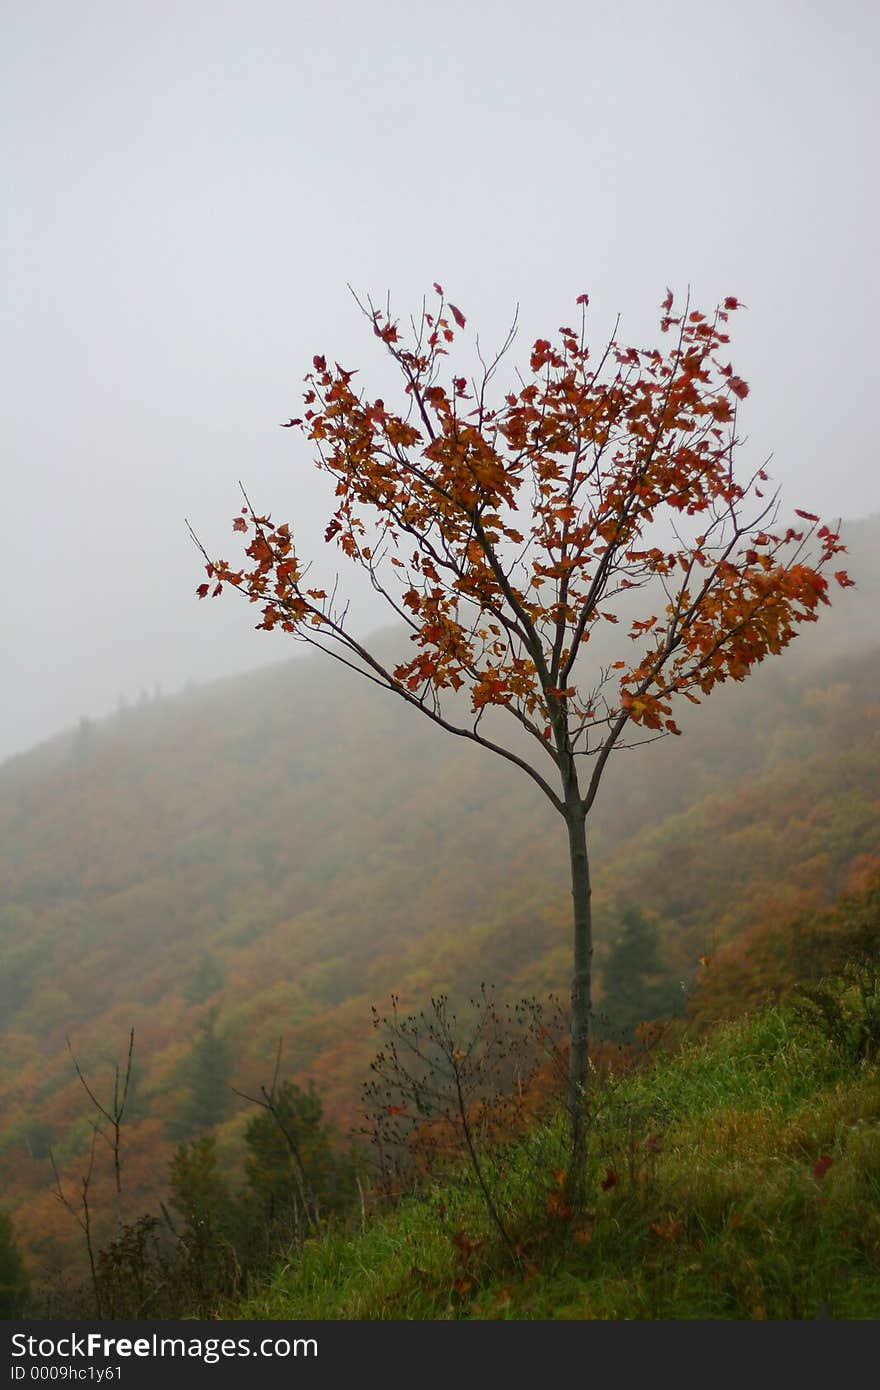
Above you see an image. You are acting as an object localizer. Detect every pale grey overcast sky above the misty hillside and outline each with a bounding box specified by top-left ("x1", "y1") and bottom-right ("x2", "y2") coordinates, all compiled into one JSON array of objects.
[{"x1": 0, "y1": 0, "x2": 880, "y2": 758}]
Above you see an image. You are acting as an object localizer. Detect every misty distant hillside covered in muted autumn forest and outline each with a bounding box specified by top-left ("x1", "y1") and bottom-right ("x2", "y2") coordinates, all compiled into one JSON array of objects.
[{"x1": 0, "y1": 521, "x2": 880, "y2": 1268}]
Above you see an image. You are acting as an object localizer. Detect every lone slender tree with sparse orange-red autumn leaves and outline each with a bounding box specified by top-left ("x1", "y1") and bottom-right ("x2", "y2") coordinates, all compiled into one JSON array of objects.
[{"x1": 196, "y1": 285, "x2": 852, "y2": 1190}]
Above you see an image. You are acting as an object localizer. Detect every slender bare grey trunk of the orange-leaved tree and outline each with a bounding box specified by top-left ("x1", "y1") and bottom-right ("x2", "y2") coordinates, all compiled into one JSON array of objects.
[{"x1": 566, "y1": 805, "x2": 592, "y2": 1205}]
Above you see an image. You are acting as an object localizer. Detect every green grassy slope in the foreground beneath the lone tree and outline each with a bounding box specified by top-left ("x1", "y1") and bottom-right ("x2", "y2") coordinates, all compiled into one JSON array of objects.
[{"x1": 222, "y1": 1008, "x2": 880, "y2": 1319}]
